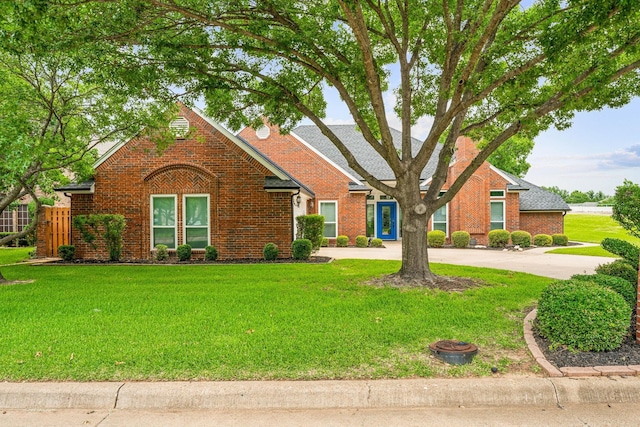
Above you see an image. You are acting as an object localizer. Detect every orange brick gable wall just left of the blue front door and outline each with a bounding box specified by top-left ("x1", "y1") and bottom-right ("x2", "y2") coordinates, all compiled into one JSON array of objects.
[{"x1": 240, "y1": 124, "x2": 366, "y2": 243}]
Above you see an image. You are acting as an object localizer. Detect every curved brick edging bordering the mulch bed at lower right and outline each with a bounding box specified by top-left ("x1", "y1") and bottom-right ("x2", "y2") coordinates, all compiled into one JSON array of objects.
[{"x1": 524, "y1": 309, "x2": 640, "y2": 377}]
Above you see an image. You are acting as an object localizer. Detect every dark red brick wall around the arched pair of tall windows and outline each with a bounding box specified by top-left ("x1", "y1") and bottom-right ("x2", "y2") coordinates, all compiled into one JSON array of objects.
[{"x1": 71, "y1": 109, "x2": 293, "y2": 260}]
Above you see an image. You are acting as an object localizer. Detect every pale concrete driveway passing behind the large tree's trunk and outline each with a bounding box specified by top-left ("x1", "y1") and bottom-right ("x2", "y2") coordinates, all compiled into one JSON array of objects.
[{"x1": 319, "y1": 242, "x2": 614, "y2": 279}]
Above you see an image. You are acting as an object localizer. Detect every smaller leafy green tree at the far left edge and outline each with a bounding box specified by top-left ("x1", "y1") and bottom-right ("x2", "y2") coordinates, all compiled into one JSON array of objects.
[{"x1": 0, "y1": 3, "x2": 175, "y2": 281}]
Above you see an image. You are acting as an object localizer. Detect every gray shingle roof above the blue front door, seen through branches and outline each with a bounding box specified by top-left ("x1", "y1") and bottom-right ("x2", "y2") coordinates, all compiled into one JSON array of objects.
[{"x1": 292, "y1": 125, "x2": 440, "y2": 181}]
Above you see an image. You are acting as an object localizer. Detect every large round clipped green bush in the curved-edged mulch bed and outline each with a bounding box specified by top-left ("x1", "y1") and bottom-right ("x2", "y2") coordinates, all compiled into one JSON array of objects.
[{"x1": 537, "y1": 280, "x2": 631, "y2": 351}]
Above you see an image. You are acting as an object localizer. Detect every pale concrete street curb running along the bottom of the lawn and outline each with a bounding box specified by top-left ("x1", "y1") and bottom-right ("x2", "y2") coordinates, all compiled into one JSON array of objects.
[{"x1": 0, "y1": 376, "x2": 640, "y2": 410}]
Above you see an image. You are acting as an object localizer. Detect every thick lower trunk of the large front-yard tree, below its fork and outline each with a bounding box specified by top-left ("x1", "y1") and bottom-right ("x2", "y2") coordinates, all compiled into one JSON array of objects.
[{"x1": 398, "y1": 201, "x2": 436, "y2": 284}]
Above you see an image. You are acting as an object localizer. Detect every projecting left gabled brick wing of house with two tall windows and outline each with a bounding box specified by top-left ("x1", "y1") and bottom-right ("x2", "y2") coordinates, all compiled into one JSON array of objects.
[{"x1": 46, "y1": 106, "x2": 314, "y2": 260}]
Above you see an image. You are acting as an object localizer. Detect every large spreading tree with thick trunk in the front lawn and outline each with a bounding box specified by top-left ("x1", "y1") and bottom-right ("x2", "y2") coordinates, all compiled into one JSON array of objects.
[{"x1": 17, "y1": 0, "x2": 640, "y2": 281}]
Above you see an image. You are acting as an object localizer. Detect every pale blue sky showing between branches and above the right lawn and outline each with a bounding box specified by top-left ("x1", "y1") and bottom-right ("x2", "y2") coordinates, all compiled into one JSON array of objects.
[{"x1": 305, "y1": 90, "x2": 640, "y2": 196}]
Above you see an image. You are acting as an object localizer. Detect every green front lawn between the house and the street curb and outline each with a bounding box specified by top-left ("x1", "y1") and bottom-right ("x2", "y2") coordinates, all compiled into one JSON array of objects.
[{"x1": 0, "y1": 260, "x2": 551, "y2": 381}]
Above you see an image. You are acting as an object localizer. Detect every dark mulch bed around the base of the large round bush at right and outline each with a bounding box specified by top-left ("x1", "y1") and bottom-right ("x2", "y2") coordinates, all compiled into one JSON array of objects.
[{"x1": 533, "y1": 315, "x2": 640, "y2": 368}]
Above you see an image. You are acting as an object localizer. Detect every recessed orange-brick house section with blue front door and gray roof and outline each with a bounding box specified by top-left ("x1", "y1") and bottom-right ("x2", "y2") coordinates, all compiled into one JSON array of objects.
[{"x1": 240, "y1": 124, "x2": 570, "y2": 244}]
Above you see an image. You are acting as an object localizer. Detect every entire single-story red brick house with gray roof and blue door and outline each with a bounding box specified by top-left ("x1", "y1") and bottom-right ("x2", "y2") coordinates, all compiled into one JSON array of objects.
[{"x1": 48, "y1": 106, "x2": 570, "y2": 260}]
